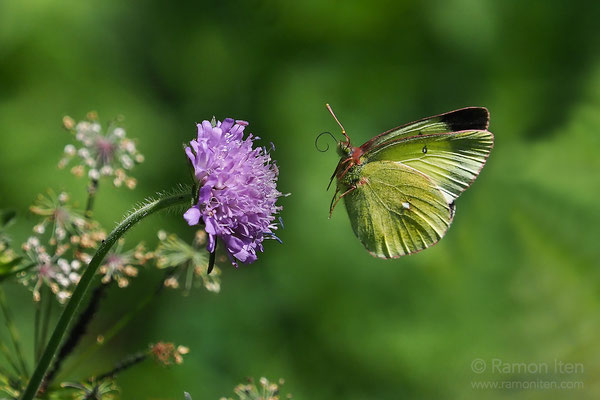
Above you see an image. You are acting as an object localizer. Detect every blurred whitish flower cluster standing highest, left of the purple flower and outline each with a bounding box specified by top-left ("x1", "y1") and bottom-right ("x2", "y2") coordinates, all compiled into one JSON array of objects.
[{"x1": 58, "y1": 113, "x2": 144, "y2": 189}]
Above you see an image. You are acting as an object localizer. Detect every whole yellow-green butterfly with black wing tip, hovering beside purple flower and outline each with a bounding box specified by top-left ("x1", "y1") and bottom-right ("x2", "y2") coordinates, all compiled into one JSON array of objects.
[{"x1": 317, "y1": 104, "x2": 494, "y2": 258}]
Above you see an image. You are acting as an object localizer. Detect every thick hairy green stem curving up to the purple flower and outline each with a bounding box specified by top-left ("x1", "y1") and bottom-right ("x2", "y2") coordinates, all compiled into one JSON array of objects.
[{"x1": 21, "y1": 192, "x2": 192, "y2": 400}]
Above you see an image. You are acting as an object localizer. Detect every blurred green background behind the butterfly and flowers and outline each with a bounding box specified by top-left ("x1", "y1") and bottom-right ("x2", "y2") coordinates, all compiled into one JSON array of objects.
[{"x1": 0, "y1": 0, "x2": 600, "y2": 400}]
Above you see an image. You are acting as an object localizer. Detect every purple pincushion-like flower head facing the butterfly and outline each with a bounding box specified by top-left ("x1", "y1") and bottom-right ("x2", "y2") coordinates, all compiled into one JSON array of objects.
[{"x1": 183, "y1": 118, "x2": 282, "y2": 266}]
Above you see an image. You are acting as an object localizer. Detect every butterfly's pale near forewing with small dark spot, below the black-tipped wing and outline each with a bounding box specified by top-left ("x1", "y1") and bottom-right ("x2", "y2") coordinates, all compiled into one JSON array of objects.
[{"x1": 364, "y1": 130, "x2": 494, "y2": 203}]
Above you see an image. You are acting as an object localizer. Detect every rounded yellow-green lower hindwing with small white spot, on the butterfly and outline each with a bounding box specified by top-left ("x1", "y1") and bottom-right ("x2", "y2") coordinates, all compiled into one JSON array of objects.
[{"x1": 344, "y1": 161, "x2": 452, "y2": 258}]
